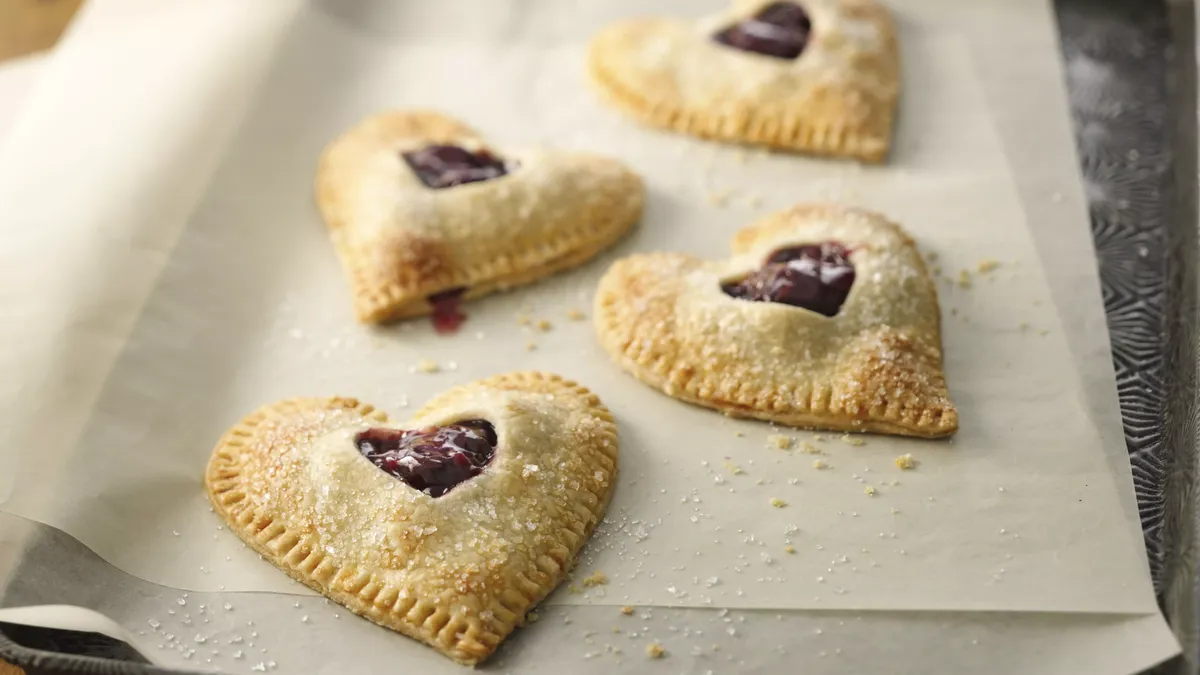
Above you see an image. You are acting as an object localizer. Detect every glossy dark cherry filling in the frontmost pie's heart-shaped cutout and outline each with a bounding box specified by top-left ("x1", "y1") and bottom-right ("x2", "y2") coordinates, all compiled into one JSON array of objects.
[{"x1": 354, "y1": 419, "x2": 497, "y2": 497}]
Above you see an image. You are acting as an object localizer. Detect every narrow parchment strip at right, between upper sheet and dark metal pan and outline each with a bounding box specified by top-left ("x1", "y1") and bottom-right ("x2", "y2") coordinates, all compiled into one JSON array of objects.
[{"x1": 954, "y1": 6, "x2": 1145, "y2": 557}]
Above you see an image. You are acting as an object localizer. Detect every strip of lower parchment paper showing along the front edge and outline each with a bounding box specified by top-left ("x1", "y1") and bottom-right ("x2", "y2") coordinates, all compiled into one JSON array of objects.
[{"x1": 0, "y1": 513, "x2": 1176, "y2": 675}]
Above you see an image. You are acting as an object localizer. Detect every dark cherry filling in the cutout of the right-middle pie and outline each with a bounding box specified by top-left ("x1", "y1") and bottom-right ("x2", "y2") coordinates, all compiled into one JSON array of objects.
[{"x1": 721, "y1": 241, "x2": 854, "y2": 316}]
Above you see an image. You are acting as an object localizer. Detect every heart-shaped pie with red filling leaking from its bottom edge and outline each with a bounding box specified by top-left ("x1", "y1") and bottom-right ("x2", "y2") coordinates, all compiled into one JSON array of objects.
[{"x1": 317, "y1": 112, "x2": 644, "y2": 331}]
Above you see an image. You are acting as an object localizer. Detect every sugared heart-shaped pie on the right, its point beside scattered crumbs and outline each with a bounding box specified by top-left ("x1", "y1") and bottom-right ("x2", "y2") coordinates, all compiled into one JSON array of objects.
[{"x1": 595, "y1": 204, "x2": 959, "y2": 437}]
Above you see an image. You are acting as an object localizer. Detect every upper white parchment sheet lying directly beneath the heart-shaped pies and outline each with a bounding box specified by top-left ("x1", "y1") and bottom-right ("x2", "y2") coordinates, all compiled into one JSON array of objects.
[{"x1": 5, "y1": 0, "x2": 1153, "y2": 611}]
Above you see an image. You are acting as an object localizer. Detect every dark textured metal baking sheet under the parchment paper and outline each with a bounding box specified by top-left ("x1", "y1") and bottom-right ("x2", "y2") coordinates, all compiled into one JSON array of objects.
[{"x1": 0, "y1": 0, "x2": 1196, "y2": 673}]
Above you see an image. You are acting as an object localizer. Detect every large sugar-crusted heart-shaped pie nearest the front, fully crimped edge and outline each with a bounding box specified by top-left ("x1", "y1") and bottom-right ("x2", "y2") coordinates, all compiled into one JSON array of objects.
[{"x1": 205, "y1": 372, "x2": 617, "y2": 664}]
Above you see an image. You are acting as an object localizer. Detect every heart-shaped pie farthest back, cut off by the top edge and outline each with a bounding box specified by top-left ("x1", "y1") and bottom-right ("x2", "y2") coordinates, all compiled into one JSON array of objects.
[{"x1": 588, "y1": 0, "x2": 900, "y2": 162}]
